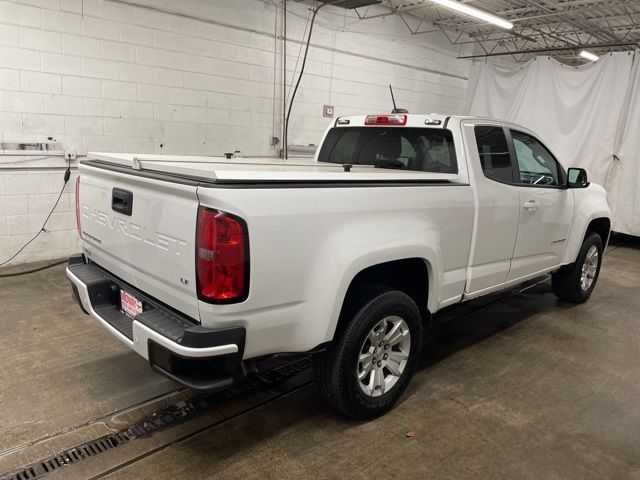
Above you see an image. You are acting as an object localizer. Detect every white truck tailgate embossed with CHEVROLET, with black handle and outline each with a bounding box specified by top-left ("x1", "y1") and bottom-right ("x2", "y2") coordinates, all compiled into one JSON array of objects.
[{"x1": 79, "y1": 164, "x2": 199, "y2": 320}]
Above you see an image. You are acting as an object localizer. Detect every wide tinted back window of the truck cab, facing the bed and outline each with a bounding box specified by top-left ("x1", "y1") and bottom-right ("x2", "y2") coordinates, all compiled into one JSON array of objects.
[{"x1": 318, "y1": 127, "x2": 458, "y2": 173}]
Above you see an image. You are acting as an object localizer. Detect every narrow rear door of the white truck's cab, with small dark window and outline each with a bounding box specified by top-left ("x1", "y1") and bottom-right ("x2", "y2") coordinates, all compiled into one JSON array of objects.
[{"x1": 463, "y1": 121, "x2": 520, "y2": 294}]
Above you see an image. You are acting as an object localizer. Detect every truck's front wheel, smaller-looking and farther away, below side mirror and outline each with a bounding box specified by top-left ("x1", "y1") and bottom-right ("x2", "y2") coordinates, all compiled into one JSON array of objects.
[{"x1": 551, "y1": 232, "x2": 603, "y2": 303}]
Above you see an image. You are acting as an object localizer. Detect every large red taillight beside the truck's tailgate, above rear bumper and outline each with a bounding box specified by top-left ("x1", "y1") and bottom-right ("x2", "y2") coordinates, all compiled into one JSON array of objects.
[{"x1": 196, "y1": 207, "x2": 249, "y2": 303}]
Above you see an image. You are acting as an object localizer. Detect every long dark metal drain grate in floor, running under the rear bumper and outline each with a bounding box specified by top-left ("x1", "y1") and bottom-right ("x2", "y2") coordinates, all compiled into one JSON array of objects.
[{"x1": 0, "y1": 357, "x2": 311, "y2": 480}]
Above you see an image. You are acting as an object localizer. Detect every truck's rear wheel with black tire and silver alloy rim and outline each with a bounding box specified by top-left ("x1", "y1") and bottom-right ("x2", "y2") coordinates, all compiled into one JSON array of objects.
[{"x1": 313, "y1": 286, "x2": 422, "y2": 420}]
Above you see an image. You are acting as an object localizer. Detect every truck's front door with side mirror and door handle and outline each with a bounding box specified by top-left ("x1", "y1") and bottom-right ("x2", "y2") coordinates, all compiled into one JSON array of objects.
[{"x1": 508, "y1": 129, "x2": 574, "y2": 281}]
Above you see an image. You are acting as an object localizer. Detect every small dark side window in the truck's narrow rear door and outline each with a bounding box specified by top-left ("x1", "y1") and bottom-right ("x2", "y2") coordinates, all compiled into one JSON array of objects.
[{"x1": 475, "y1": 126, "x2": 514, "y2": 183}]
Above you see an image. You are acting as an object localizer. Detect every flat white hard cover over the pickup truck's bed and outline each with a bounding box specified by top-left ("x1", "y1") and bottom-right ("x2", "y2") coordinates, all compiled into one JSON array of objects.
[{"x1": 88, "y1": 152, "x2": 460, "y2": 183}]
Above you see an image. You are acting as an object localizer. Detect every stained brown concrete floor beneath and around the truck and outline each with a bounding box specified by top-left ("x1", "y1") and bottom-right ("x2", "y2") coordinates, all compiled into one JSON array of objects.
[{"x1": 0, "y1": 237, "x2": 640, "y2": 480}]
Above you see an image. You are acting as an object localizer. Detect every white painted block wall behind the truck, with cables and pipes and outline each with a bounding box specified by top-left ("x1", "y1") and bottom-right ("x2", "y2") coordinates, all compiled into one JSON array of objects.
[{"x1": 0, "y1": 0, "x2": 468, "y2": 263}]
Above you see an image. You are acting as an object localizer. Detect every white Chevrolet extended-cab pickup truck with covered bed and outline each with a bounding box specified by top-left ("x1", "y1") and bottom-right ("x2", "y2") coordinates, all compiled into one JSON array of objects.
[{"x1": 67, "y1": 114, "x2": 610, "y2": 418}]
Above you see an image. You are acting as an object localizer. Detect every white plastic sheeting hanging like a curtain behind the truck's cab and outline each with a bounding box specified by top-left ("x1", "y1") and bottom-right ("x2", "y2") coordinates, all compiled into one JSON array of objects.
[{"x1": 466, "y1": 53, "x2": 640, "y2": 235}]
